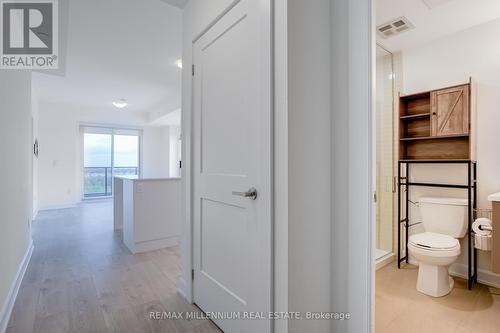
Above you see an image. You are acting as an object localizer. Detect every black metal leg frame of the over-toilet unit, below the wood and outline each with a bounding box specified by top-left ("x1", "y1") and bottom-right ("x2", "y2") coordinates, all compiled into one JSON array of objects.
[{"x1": 398, "y1": 160, "x2": 477, "y2": 290}]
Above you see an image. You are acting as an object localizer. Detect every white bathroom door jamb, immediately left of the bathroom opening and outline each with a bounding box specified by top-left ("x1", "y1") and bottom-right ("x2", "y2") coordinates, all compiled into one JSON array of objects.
[{"x1": 347, "y1": 0, "x2": 375, "y2": 333}]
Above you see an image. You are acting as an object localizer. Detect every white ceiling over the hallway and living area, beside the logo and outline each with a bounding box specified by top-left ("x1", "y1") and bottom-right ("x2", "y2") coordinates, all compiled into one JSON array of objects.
[{"x1": 33, "y1": 0, "x2": 182, "y2": 112}]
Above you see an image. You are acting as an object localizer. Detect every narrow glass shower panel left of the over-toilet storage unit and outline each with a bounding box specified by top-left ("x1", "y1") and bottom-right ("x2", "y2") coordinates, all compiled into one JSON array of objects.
[{"x1": 375, "y1": 45, "x2": 394, "y2": 260}]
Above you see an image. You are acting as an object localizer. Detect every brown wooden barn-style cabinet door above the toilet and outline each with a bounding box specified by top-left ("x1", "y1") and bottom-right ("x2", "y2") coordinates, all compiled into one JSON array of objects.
[{"x1": 431, "y1": 85, "x2": 469, "y2": 136}]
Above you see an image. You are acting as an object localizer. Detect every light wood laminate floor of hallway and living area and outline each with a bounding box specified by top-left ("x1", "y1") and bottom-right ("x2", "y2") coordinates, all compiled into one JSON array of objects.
[{"x1": 7, "y1": 200, "x2": 220, "y2": 333}]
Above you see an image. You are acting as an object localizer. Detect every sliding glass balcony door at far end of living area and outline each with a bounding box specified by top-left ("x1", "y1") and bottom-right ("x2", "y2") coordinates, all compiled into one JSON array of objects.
[{"x1": 82, "y1": 127, "x2": 140, "y2": 198}]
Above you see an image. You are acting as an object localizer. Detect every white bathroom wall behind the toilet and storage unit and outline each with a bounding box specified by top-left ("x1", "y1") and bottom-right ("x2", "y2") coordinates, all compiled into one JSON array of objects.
[{"x1": 402, "y1": 19, "x2": 500, "y2": 278}]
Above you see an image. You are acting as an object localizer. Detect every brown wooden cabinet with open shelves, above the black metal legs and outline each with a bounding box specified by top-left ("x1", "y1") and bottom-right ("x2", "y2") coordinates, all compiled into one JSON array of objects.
[{"x1": 399, "y1": 84, "x2": 474, "y2": 160}]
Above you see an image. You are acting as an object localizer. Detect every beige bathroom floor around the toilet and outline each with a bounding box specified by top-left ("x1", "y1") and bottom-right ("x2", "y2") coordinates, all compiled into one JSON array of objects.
[{"x1": 375, "y1": 263, "x2": 500, "y2": 333}]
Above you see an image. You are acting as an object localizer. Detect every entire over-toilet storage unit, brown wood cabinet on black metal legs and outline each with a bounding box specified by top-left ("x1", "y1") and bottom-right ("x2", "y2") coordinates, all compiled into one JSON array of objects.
[{"x1": 398, "y1": 79, "x2": 477, "y2": 289}]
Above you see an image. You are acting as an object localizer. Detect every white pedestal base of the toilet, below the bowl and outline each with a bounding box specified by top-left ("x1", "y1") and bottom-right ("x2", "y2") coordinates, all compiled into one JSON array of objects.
[{"x1": 417, "y1": 262, "x2": 454, "y2": 297}]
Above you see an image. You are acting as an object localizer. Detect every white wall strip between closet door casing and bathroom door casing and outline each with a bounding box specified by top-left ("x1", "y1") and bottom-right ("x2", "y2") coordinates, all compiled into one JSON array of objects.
[{"x1": 288, "y1": 0, "x2": 331, "y2": 333}]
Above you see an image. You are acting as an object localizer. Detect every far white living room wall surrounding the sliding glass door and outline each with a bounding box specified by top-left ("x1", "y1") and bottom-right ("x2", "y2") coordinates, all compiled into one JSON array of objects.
[{"x1": 38, "y1": 101, "x2": 174, "y2": 209}]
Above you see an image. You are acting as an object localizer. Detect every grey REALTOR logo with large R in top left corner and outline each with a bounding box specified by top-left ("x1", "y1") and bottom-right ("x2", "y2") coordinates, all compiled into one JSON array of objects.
[{"x1": 0, "y1": 0, "x2": 58, "y2": 69}]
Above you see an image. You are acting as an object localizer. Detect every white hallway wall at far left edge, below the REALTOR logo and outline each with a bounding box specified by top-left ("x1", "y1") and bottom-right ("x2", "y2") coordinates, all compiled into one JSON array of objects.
[{"x1": 0, "y1": 70, "x2": 33, "y2": 330}]
